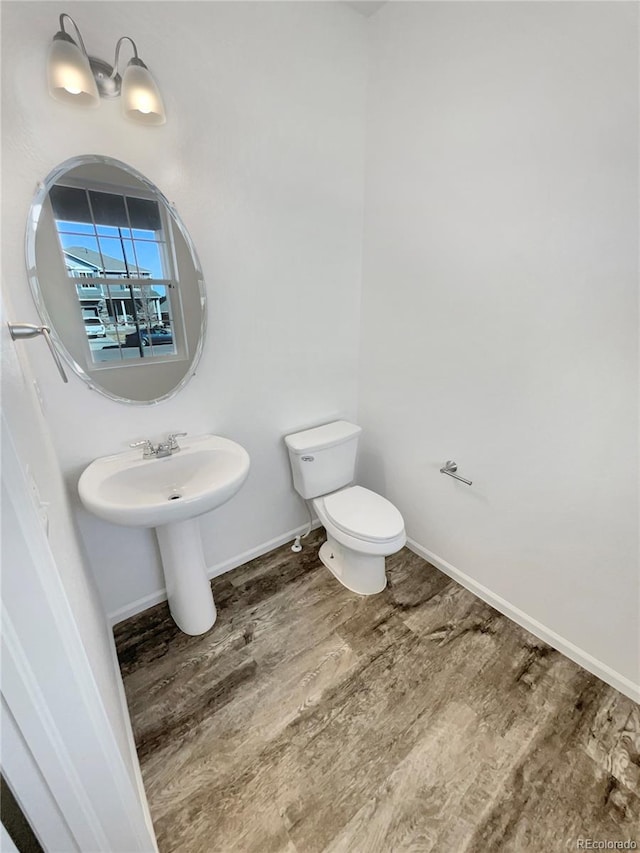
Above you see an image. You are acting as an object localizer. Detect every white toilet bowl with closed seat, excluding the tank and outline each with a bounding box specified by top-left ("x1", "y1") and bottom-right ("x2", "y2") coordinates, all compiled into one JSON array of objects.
[{"x1": 313, "y1": 486, "x2": 407, "y2": 595}]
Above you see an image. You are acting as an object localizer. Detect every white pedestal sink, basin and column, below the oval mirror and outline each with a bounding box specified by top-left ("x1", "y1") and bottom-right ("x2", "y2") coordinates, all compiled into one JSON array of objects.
[{"x1": 78, "y1": 435, "x2": 249, "y2": 634}]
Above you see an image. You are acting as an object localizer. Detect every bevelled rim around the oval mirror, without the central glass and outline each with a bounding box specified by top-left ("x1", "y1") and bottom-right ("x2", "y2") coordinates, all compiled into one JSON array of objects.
[{"x1": 25, "y1": 154, "x2": 207, "y2": 406}]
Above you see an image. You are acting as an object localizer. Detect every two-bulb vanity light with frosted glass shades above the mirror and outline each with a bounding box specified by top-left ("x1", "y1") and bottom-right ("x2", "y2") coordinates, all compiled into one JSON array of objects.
[{"x1": 47, "y1": 12, "x2": 167, "y2": 124}]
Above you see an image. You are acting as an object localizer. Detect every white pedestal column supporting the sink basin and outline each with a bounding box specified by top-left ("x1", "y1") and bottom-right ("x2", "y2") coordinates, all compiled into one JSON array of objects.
[{"x1": 156, "y1": 518, "x2": 216, "y2": 636}]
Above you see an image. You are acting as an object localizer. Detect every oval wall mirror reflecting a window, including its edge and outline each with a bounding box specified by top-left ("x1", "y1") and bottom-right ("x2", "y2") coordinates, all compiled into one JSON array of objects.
[{"x1": 26, "y1": 155, "x2": 206, "y2": 405}]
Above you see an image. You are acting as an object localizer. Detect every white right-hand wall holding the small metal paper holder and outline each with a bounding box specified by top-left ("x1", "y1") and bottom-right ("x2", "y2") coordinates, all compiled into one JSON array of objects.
[{"x1": 359, "y1": 2, "x2": 640, "y2": 683}]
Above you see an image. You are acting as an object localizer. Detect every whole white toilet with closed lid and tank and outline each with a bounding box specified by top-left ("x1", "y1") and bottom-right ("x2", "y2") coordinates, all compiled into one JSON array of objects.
[{"x1": 285, "y1": 421, "x2": 407, "y2": 595}]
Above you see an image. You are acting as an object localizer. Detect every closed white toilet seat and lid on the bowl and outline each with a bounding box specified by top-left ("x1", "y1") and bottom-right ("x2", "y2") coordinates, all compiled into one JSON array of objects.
[{"x1": 323, "y1": 486, "x2": 404, "y2": 542}]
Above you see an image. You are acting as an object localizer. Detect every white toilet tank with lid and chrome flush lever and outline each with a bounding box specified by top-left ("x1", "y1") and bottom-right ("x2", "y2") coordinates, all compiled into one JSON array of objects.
[{"x1": 284, "y1": 421, "x2": 362, "y2": 500}]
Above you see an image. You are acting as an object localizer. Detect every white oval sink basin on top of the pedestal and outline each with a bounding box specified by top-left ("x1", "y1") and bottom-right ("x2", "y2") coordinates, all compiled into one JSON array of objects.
[{"x1": 78, "y1": 435, "x2": 249, "y2": 527}]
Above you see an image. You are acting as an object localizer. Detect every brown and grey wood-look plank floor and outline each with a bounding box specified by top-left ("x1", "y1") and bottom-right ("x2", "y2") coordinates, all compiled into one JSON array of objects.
[{"x1": 115, "y1": 531, "x2": 640, "y2": 853}]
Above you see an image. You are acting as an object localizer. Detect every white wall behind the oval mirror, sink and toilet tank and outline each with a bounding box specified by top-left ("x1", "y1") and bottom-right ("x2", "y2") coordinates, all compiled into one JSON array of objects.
[{"x1": 2, "y1": 2, "x2": 365, "y2": 613}]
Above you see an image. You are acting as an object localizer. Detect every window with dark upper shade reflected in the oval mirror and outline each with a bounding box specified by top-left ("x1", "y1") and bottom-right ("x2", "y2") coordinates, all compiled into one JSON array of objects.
[{"x1": 49, "y1": 184, "x2": 177, "y2": 364}]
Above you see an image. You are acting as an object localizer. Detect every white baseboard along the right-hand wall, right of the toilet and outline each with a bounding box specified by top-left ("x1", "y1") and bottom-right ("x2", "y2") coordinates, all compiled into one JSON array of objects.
[{"x1": 407, "y1": 539, "x2": 640, "y2": 702}]
